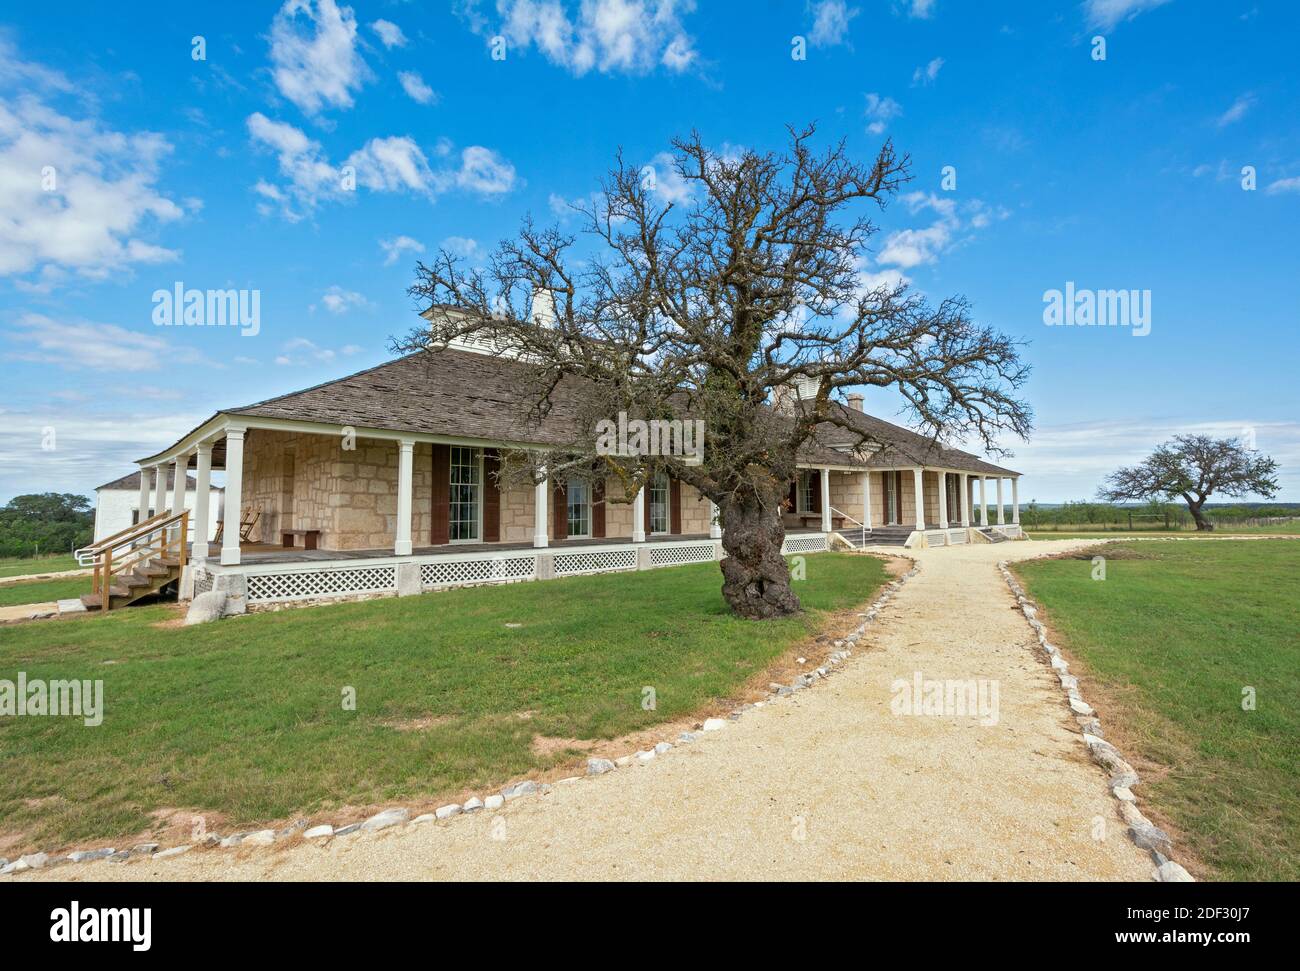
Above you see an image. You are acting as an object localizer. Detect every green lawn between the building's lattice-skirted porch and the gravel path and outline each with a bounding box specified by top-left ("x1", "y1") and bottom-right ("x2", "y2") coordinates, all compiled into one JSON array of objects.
[{"x1": 0, "y1": 554, "x2": 887, "y2": 858}]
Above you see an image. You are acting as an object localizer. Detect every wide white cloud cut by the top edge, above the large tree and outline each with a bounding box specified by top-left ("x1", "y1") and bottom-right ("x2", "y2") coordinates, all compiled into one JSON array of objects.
[{"x1": 459, "y1": 0, "x2": 698, "y2": 77}]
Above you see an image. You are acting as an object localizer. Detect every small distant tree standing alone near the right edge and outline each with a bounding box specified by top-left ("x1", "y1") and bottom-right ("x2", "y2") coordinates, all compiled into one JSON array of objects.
[{"x1": 1097, "y1": 435, "x2": 1278, "y2": 532}]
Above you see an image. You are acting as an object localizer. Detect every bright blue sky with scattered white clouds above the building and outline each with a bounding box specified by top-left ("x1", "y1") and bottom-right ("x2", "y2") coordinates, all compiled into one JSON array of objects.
[{"x1": 0, "y1": 0, "x2": 1300, "y2": 502}]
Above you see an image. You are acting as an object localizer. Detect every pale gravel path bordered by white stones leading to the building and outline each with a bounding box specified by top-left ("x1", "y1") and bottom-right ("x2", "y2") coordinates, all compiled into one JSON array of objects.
[{"x1": 25, "y1": 541, "x2": 1153, "y2": 880}]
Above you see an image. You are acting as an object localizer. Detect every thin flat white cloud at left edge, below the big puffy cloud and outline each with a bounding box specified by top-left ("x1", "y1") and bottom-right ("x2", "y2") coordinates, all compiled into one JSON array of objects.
[{"x1": 5, "y1": 313, "x2": 195, "y2": 373}]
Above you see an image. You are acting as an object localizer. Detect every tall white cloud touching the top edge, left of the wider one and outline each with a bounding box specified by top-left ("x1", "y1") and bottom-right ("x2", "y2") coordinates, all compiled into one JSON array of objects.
[{"x1": 270, "y1": 0, "x2": 371, "y2": 114}]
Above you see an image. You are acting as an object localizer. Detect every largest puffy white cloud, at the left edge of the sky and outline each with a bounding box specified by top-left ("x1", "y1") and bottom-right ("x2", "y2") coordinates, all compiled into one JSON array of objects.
[{"x1": 0, "y1": 36, "x2": 185, "y2": 284}]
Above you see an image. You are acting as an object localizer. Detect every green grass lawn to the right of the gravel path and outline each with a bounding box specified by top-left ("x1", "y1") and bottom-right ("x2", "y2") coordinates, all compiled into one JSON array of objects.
[{"x1": 1013, "y1": 542, "x2": 1300, "y2": 880}]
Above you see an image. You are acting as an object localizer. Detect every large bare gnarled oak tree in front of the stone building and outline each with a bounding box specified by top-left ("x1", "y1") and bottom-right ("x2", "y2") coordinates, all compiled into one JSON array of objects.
[{"x1": 393, "y1": 126, "x2": 1031, "y2": 619}]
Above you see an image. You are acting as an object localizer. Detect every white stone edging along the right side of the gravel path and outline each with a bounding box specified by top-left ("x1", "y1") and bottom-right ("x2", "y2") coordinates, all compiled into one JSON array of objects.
[{"x1": 997, "y1": 554, "x2": 1193, "y2": 884}]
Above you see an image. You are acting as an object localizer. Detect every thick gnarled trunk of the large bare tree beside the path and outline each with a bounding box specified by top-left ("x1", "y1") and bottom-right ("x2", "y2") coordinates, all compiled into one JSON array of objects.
[{"x1": 719, "y1": 487, "x2": 800, "y2": 620}]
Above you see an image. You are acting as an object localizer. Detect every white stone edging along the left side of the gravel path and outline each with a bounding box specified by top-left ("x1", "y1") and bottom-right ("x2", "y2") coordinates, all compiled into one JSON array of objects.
[{"x1": 0, "y1": 551, "x2": 920, "y2": 876}]
